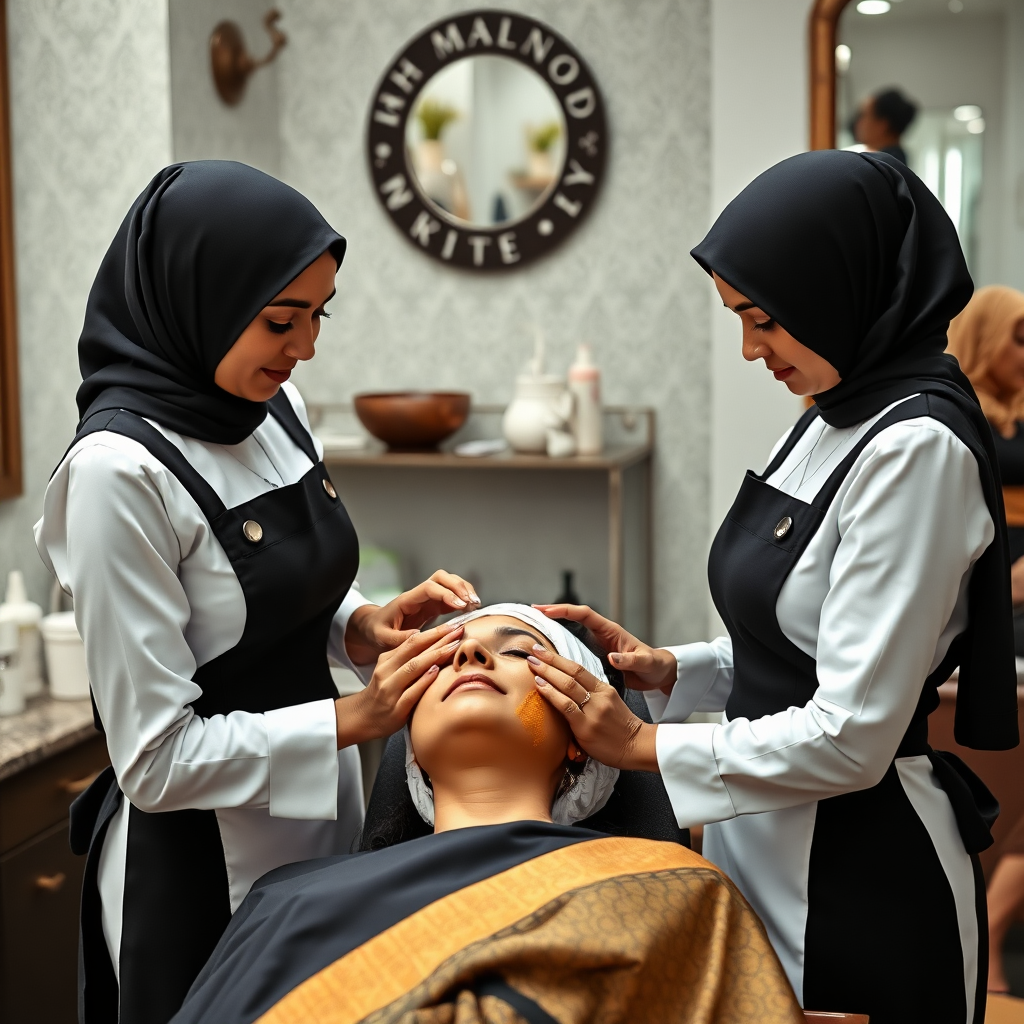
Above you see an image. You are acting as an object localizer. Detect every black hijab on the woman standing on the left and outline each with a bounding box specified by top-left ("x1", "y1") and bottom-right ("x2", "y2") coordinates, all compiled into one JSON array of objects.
[{"x1": 78, "y1": 160, "x2": 345, "y2": 444}]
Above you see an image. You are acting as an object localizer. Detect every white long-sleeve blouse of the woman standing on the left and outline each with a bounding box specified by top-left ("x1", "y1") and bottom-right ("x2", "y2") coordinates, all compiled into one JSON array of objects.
[{"x1": 35, "y1": 384, "x2": 366, "y2": 820}]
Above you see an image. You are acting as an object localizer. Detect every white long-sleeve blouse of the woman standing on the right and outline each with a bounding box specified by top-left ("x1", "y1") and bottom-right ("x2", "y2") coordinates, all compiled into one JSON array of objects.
[{"x1": 648, "y1": 395, "x2": 994, "y2": 826}]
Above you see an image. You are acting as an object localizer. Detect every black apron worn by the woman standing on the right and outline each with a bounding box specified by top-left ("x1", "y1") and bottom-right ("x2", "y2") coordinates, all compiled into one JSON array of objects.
[{"x1": 708, "y1": 395, "x2": 998, "y2": 1024}]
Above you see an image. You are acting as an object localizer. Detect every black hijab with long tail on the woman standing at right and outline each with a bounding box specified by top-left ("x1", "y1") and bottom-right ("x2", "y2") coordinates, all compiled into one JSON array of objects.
[{"x1": 691, "y1": 150, "x2": 1017, "y2": 750}]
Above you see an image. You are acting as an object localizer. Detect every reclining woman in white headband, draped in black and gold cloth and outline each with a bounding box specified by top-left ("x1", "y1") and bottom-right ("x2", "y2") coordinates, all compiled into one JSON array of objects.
[{"x1": 174, "y1": 604, "x2": 803, "y2": 1024}]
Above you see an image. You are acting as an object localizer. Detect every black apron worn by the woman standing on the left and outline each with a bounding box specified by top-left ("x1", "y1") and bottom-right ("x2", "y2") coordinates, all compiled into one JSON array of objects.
[{"x1": 65, "y1": 392, "x2": 358, "y2": 1024}]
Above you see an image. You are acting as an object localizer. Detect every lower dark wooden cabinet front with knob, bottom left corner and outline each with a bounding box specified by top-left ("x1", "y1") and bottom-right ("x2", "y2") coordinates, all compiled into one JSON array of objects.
[{"x1": 0, "y1": 824, "x2": 85, "y2": 1024}]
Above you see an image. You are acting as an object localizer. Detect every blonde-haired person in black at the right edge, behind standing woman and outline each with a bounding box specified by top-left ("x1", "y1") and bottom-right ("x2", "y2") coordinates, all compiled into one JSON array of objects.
[{"x1": 947, "y1": 285, "x2": 1024, "y2": 655}]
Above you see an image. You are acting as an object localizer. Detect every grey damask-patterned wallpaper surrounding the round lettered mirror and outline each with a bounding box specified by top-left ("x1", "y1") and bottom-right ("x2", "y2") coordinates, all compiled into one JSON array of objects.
[{"x1": 278, "y1": 0, "x2": 710, "y2": 642}]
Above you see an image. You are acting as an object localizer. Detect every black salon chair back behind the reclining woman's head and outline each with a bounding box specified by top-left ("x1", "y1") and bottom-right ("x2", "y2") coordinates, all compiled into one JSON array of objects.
[{"x1": 359, "y1": 688, "x2": 690, "y2": 850}]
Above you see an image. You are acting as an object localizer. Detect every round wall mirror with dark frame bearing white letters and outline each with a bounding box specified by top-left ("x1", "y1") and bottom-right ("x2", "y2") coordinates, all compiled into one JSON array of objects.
[{"x1": 368, "y1": 10, "x2": 607, "y2": 270}]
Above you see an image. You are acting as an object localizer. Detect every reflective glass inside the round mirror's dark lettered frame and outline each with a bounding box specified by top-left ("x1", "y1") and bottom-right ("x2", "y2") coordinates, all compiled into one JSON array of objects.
[{"x1": 406, "y1": 54, "x2": 565, "y2": 227}]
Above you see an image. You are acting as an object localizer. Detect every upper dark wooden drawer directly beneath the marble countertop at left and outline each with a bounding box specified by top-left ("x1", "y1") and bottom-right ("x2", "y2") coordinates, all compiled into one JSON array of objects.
[{"x1": 0, "y1": 736, "x2": 110, "y2": 854}]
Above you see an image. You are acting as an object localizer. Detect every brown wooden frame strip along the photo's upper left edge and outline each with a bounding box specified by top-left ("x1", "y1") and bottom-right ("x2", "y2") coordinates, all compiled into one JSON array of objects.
[{"x1": 0, "y1": 0, "x2": 23, "y2": 499}]
